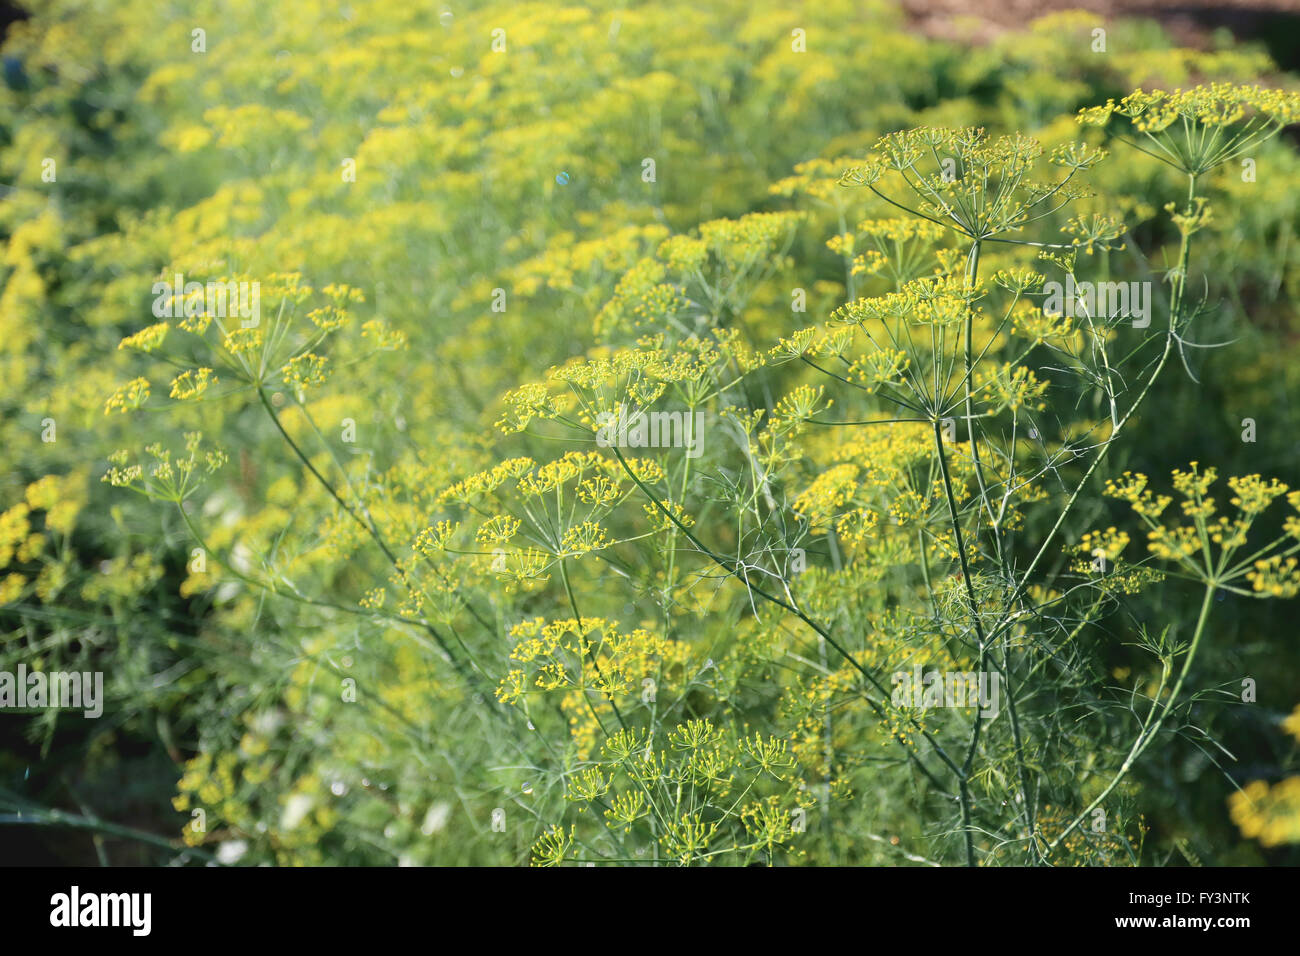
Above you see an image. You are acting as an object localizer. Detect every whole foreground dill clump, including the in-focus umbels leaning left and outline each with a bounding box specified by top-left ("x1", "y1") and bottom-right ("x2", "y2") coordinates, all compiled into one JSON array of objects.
[{"x1": 94, "y1": 86, "x2": 1300, "y2": 865}]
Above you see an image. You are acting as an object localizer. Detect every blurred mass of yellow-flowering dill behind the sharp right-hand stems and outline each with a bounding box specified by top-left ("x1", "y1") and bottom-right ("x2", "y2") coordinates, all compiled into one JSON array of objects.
[{"x1": 0, "y1": 0, "x2": 1300, "y2": 864}]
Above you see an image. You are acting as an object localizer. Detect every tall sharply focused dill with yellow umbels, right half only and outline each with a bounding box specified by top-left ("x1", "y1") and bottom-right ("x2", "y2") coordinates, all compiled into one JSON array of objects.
[{"x1": 467, "y1": 85, "x2": 1300, "y2": 865}]
